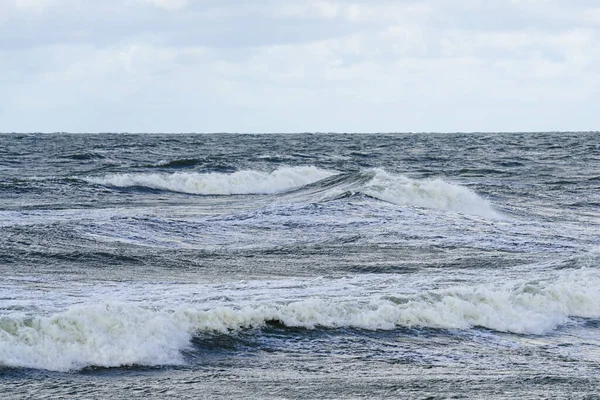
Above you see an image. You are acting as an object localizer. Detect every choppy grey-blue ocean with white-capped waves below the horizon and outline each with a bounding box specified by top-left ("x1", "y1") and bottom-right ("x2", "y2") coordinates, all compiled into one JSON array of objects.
[{"x1": 0, "y1": 132, "x2": 600, "y2": 399}]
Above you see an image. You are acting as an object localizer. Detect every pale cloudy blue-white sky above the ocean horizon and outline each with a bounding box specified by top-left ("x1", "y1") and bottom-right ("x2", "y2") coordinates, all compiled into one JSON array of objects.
[{"x1": 0, "y1": 0, "x2": 600, "y2": 132}]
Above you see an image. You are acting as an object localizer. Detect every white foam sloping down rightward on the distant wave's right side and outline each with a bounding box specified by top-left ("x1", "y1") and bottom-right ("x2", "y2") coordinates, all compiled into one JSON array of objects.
[{"x1": 363, "y1": 169, "x2": 499, "y2": 217}]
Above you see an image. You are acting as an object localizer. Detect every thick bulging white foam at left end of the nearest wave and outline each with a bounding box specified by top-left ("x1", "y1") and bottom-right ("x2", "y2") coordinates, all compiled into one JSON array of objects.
[{"x1": 0, "y1": 304, "x2": 190, "y2": 371}]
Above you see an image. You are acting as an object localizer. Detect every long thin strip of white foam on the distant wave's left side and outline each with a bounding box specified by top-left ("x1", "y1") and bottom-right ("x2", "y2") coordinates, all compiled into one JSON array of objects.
[{"x1": 85, "y1": 166, "x2": 334, "y2": 195}]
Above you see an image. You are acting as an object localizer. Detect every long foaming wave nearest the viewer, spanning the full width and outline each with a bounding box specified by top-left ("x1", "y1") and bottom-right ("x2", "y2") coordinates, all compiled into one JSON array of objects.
[{"x1": 0, "y1": 270, "x2": 600, "y2": 371}]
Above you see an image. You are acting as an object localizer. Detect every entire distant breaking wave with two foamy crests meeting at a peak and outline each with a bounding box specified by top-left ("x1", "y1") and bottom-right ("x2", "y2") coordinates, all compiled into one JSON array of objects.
[{"x1": 85, "y1": 166, "x2": 499, "y2": 217}]
